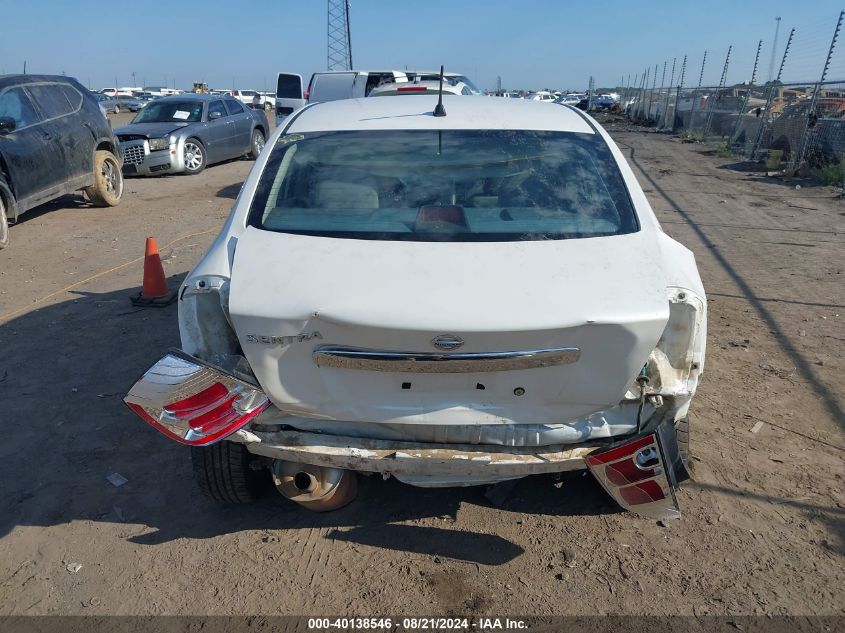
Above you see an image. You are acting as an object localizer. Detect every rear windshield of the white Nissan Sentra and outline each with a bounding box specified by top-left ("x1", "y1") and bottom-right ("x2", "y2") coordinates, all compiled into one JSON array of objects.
[{"x1": 250, "y1": 130, "x2": 638, "y2": 242}]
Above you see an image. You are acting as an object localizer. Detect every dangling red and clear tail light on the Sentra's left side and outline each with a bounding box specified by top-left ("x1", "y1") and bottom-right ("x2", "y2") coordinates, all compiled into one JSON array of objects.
[{"x1": 123, "y1": 351, "x2": 270, "y2": 446}]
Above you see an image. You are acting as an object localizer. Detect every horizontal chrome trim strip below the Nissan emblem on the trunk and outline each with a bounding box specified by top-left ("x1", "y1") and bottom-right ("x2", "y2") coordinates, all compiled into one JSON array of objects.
[{"x1": 312, "y1": 345, "x2": 581, "y2": 374}]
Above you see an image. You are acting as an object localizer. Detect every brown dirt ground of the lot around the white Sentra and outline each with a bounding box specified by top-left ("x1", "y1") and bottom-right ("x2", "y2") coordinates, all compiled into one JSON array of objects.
[{"x1": 0, "y1": 113, "x2": 845, "y2": 616}]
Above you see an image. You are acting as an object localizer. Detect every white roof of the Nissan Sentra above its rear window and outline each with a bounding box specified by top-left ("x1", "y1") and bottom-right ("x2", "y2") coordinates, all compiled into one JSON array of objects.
[{"x1": 287, "y1": 95, "x2": 594, "y2": 134}]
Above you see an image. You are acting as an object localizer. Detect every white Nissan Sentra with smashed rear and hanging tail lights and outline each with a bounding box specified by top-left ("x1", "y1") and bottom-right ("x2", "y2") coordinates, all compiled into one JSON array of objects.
[{"x1": 125, "y1": 96, "x2": 706, "y2": 518}]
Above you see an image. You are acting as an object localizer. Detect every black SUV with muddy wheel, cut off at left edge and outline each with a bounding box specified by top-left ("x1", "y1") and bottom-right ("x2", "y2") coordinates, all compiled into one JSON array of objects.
[{"x1": 0, "y1": 75, "x2": 123, "y2": 248}]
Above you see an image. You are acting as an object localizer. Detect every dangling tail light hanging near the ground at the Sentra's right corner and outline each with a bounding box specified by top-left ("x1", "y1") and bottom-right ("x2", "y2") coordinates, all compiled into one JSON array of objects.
[{"x1": 585, "y1": 422, "x2": 689, "y2": 519}]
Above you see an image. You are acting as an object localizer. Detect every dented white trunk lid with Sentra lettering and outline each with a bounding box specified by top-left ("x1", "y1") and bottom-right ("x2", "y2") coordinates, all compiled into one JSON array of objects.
[{"x1": 229, "y1": 227, "x2": 669, "y2": 424}]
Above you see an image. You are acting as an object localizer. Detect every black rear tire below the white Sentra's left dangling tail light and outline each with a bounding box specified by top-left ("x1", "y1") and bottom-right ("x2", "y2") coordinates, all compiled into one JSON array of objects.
[{"x1": 191, "y1": 440, "x2": 271, "y2": 503}]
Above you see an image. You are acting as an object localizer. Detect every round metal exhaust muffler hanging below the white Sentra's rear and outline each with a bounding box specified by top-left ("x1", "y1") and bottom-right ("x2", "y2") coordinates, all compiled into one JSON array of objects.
[{"x1": 273, "y1": 460, "x2": 358, "y2": 512}]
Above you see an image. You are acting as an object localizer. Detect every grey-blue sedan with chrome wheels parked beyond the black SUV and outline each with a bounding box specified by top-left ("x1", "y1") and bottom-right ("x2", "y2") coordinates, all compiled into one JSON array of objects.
[{"x1": 115, "y1": 94, "x2": 270, "y2": 176}]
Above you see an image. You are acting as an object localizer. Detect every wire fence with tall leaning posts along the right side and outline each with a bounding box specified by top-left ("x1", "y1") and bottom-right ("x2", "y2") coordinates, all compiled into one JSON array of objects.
[{"x1": 619, "y1": 11, "x2": 845, "y2": 184}]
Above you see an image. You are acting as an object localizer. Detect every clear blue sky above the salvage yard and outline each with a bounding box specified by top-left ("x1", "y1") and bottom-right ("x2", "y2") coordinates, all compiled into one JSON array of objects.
[{"x1": 0, "y1": 0, "x2": 845, "y2": 89}]
